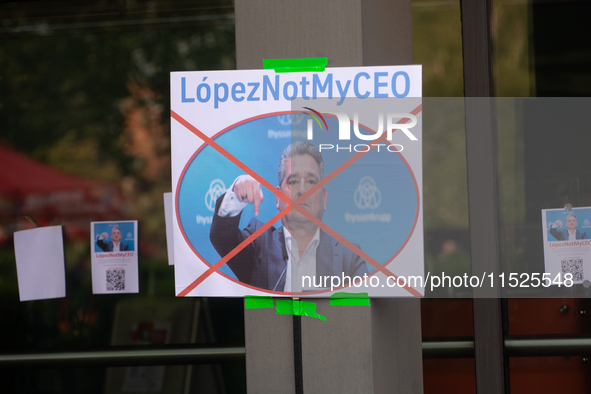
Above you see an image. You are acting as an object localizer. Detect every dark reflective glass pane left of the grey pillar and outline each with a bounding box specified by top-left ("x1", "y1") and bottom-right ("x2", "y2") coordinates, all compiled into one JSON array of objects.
[{"x1": 0, "y1": 0, "x2": 245, "y2": 392}]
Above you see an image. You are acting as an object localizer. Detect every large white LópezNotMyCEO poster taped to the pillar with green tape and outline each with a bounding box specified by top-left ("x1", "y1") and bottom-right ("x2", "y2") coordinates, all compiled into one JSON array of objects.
[{"x1": 171, "y1": 66, "x2": 424, "y2": 297}]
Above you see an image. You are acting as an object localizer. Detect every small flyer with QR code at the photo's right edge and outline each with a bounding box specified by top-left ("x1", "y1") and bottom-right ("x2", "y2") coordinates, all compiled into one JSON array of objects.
[{"x1": 542, "y1": 207, "x2": 591, "y2": 284}]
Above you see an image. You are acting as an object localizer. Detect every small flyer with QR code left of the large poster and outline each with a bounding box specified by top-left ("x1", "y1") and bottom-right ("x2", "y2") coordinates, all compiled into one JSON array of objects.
[{"x1": 90, "y1": 220, "x2": 139, "y2": 294}]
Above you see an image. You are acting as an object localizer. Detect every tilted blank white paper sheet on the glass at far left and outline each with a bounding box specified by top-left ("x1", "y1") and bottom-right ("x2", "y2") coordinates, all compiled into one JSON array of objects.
[{"x1": 14, "y1": 226, "x2": 66, "y2": 301}]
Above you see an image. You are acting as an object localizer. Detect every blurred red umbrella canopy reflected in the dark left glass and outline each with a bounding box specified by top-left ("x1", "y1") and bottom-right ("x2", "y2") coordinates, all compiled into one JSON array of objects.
[{"x1": 0, "y1": 144, "x2": 123, "y2": 242}]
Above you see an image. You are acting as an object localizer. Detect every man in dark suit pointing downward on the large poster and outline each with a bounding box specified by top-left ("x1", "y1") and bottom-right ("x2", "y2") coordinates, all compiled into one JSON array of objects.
[{"x1": 210, "y1": 141, "x2": 367, "y2": 292}]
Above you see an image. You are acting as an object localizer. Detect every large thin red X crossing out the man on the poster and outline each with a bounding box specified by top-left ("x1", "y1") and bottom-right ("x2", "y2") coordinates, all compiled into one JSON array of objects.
[{"x1": 170, "y1": 105, "x2": 422, "y2": 297}]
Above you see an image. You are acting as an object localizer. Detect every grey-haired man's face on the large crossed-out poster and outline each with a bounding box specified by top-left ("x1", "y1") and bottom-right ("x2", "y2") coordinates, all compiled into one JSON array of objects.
[{"x1": 277, "y1": 155, "x2": 327, "y2": 228}]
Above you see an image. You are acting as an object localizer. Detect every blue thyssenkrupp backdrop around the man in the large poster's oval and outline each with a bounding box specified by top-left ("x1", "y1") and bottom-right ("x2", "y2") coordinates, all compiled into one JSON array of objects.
[{"x1": 178, "y1": 116, "x2": 417, "y2": 277}]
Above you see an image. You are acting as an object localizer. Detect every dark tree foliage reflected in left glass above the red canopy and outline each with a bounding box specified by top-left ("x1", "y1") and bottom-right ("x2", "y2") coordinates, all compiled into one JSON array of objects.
[{"x1": 0, "y1": 22, "x2": 235, "y2": 258}]
